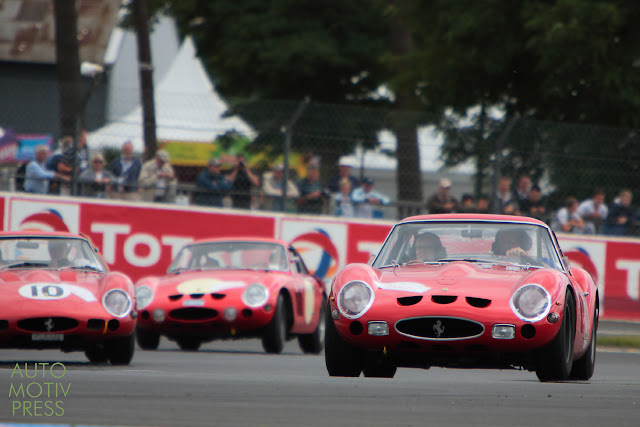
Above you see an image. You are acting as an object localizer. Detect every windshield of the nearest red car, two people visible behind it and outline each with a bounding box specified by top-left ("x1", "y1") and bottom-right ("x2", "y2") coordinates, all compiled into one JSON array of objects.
[{"x1": 373, "y1": 221, "x2": 563, "y2": 270}]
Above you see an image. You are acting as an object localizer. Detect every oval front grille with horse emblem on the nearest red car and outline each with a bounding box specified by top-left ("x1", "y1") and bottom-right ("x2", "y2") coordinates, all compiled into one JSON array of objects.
[{"x1": 396, "y1": 317, "x2": 484, "y2": 340}]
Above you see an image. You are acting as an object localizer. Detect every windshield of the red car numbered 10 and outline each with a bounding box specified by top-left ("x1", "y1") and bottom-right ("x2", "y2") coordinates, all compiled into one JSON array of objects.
[{"x1": 0, "y1": 237, "x2": 105, "y2": 272}]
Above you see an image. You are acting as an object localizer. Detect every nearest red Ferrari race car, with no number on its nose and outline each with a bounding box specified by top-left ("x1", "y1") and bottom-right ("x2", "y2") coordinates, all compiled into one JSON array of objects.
[{"x1": 325, "y1": 214, "x2": 599, "y2": 381}]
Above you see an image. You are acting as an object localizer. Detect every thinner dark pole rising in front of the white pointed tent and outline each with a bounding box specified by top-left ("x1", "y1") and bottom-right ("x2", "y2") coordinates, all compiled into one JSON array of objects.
[{"x1": 132, "y1": 0, "x2": 157, "y2": 159}]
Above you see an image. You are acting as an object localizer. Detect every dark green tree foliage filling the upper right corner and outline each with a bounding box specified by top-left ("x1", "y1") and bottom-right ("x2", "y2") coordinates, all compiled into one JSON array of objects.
[{"x1": 400, "y1": 0, "x2": 640, "y2": 196}]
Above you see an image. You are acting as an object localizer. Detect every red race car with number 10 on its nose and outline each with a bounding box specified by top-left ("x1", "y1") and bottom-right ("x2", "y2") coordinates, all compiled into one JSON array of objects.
[{"x1": 0, "y1": 232, "x2": 136, "y2": 365}]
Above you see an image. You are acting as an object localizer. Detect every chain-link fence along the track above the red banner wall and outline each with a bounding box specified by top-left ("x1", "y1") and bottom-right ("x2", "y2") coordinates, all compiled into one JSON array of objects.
[{"x1": 0, "y1": 93, "x2": 640, "y2": 233}]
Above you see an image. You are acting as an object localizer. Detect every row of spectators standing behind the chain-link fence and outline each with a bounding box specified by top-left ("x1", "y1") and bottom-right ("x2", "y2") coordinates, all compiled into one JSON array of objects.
[{"x1": 19, "y1": 135, "x2": 640, "y2": 236}]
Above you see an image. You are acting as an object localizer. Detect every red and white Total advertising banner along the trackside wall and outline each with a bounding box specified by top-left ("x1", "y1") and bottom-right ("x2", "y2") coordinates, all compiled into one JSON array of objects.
[{"x1": 0, "y1": 193, "x2": 640, "y2": 321}]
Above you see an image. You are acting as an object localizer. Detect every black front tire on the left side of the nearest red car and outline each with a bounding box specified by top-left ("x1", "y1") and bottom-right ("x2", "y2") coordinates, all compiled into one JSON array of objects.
[{"x1": 324, "y1": 304, "x2": 365, "y2": 377}]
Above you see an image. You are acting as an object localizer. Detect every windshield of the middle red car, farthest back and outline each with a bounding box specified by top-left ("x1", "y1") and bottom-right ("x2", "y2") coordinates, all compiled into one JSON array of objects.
[{"x1": 167, "y1": 242, "x2": 289, "y2": 273}]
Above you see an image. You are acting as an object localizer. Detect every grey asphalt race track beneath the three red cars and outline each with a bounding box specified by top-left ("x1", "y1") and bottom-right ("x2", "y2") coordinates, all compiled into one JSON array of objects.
[{"x1": 0, "y1": 340, "x2": 640, "y2": 427}]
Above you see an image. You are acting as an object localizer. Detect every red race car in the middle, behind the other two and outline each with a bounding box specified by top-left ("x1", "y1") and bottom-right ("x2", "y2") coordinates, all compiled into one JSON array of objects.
[{"x1": 136, "y1": 238, "x2": 326, "y2": 353}]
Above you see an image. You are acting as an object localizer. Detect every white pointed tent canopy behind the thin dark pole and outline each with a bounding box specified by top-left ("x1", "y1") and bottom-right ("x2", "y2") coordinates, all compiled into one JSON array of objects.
[{"x1": 89, "y1": 37, "x2": 254, "y2": 152}]
